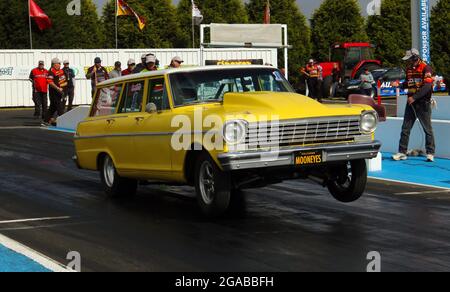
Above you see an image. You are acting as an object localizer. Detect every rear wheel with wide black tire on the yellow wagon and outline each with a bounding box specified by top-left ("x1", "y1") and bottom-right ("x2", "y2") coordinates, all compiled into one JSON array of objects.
[{"x1": 100, "y1": 155, "x2": 138, "y2": 198}]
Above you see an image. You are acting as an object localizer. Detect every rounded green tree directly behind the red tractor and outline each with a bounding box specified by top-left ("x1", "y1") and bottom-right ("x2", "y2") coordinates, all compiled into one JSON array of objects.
[{"x1": 311, "y1": 0, "x2": 368, "y2": 60}]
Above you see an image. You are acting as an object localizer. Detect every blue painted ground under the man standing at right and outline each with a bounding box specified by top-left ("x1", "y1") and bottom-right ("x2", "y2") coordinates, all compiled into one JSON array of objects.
[{"x1": 369, "y1": 153, "x2": 450, "y2": 189}]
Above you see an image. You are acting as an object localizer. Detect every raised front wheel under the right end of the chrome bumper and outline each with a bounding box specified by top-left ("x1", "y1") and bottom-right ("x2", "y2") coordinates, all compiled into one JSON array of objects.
[{"x1": 327, "y1": 159, "x2": 367, "y2": 203}]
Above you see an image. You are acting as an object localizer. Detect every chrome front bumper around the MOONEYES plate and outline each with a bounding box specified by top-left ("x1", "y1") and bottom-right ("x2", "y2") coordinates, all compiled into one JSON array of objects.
[{"x1": 218, "y1": 141, "x2": 381, "y2": 171}]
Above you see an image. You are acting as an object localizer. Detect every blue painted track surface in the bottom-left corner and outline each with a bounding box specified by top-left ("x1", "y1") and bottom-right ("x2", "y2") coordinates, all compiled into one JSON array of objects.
[{"x1": 0, "y1": 245, "x2": 50, "y2": 272}]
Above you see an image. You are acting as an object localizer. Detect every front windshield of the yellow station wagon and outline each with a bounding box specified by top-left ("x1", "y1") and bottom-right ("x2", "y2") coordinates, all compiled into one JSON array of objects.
[{"x1": 170, "y1": 68, "x2": 294, "y2": 106}]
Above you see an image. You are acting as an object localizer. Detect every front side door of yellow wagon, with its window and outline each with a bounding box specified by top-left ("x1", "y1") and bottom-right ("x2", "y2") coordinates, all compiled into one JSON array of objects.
[{"x1": 135, "y1": 76, "x2": 174, "y2": 179}]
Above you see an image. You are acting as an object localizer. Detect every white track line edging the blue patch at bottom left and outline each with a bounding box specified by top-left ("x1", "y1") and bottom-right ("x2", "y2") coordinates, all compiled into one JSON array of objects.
[{"x1": 0, "y1": 234, "x2": 73, "y2": 272}]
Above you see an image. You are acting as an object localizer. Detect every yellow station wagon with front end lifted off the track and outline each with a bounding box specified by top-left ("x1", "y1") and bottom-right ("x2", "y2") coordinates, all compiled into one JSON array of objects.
[{"x1": 74, "y1": 66, "x2": 381, "y2": 216}]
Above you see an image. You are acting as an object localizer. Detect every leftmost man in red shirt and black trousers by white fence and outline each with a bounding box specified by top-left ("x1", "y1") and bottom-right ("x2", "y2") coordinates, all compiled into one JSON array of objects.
[{"x1": 30, "y1": 61, "x2": 48, "y2": 120}]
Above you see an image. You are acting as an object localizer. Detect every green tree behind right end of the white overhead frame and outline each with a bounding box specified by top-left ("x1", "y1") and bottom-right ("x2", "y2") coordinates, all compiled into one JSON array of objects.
[{"x1": 246, "y1": 0, "x2": 311, "y2": 83}]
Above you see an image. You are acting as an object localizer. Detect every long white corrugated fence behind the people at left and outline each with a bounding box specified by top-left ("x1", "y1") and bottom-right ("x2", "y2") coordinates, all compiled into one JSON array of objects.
[{"x1": 0, "y1": 48, "x2": 278, "y2": 107}]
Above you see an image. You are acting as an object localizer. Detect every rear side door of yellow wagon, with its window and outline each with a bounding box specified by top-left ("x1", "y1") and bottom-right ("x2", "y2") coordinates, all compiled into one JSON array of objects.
[{"x1": 107, "y1": 79, "x2": 146, "y2": 173}]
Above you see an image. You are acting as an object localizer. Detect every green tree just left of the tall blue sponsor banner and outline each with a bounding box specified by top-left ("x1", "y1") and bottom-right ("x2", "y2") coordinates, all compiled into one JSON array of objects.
[{"x1": 366, "y1": 0, "x2": 412, "y2": 66}]
